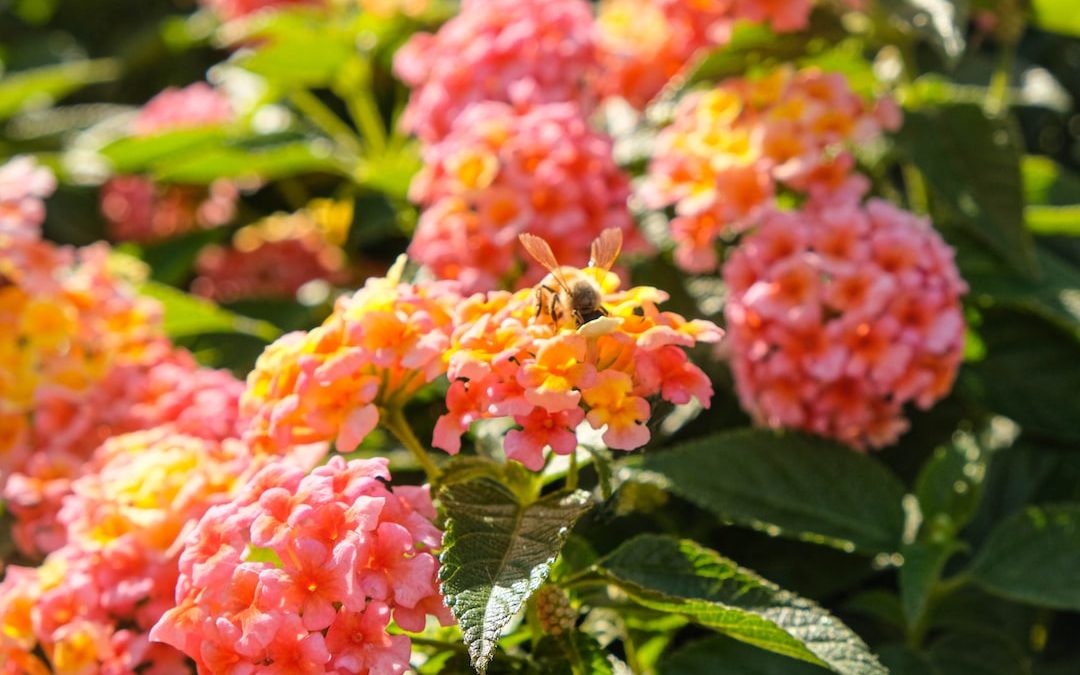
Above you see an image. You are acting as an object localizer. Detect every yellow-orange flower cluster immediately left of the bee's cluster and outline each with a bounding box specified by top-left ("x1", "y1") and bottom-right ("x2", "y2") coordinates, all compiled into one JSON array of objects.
[{"x1": 241, "y1": 259, "x2": 460, "y2": 454}]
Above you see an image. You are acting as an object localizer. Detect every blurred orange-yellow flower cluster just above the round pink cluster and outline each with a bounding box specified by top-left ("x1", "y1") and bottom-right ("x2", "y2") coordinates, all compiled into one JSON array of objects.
[{"x1": 642, "y1": 67, "x2": 900, "y2": 272}]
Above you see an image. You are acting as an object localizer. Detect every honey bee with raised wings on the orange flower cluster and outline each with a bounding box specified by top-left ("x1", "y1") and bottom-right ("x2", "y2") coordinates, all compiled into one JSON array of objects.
[{"x1": 517, "y1": 228, "x2": 622, "y2": 337}]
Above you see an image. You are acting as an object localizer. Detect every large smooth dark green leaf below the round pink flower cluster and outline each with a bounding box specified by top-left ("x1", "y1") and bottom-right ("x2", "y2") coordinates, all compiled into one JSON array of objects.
[{"x1": 642, "y1": 429, "x2": 905, "y2": 553}]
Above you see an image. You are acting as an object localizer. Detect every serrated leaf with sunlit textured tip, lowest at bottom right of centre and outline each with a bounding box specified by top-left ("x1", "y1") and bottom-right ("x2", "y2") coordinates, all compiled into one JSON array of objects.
[{"x1": 595, "y1": 535, "x2": 887, "y2": 675}]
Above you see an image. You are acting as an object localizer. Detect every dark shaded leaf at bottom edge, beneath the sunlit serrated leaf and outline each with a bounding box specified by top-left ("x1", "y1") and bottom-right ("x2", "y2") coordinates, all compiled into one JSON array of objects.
[{"x1": 657, "y1": 635, "x2": 827, "y2": 675}]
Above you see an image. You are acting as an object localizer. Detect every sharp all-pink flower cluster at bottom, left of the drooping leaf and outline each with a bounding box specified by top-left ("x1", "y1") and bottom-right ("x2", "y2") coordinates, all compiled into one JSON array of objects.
[{"x1": 150, "y1": 457, "x2": 451, "y2": 675}]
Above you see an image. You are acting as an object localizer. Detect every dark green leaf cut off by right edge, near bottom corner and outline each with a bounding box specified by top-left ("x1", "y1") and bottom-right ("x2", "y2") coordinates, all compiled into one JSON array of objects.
[{"x1": 971, "y1": 503, "x2": 1080, "y2": 611}]
